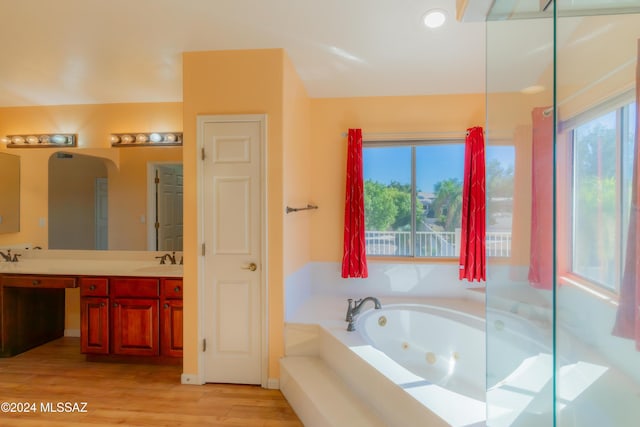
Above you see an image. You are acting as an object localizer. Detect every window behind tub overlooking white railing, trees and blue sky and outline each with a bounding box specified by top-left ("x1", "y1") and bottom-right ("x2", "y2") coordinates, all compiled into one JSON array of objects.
[{"x1": 363, "y1": 141, "x2": 515, "y2": 257}]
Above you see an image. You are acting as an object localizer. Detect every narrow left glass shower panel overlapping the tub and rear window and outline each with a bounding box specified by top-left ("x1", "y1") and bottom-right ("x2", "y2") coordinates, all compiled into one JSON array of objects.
[{"x1": 486, "y1": 4, "x2": 554, "y2": 427}]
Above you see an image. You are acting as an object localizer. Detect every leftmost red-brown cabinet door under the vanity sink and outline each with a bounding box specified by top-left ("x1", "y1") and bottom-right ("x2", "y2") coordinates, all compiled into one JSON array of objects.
[{"x1": 80, "y1": 297, "x2": 109, "y2": 354}]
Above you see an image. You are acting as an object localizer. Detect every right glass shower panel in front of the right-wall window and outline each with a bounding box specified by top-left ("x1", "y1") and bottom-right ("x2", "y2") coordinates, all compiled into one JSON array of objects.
[{"x1": 555, "y1": 7, "x2": 640, "y2": 427}]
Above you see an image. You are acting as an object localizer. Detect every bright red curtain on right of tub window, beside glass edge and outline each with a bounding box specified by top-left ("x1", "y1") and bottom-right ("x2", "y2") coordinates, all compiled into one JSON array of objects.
[{"x1": 459, "y1": 127, "x2": 487, "y2": 282}]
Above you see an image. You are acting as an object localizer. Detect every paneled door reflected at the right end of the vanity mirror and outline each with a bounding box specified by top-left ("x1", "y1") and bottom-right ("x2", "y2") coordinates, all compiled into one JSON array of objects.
[{"x1": 156, "y1": 165, "x2": 183, "y2": 251}]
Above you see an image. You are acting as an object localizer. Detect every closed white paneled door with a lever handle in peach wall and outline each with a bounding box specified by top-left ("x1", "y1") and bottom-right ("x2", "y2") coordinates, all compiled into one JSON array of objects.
[{"x1": 200, "y1": 116, "x2": 264, "y2": 384}]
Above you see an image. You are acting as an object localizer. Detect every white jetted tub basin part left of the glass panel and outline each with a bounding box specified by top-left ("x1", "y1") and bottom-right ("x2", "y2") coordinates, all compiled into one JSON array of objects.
[{"x1": 356, "y1": 304, "x2": 486, "y2": 402}]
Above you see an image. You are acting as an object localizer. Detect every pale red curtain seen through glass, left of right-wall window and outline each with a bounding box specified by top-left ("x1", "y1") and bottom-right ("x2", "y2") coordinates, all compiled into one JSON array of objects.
[{"x1": 529, "y1": 107, "x2": 554, "y2": 289}]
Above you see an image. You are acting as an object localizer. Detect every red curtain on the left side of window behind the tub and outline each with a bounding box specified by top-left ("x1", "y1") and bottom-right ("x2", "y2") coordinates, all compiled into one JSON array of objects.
[{"x1": 342, "y1": 129, "x2": 369, "y2": 278}]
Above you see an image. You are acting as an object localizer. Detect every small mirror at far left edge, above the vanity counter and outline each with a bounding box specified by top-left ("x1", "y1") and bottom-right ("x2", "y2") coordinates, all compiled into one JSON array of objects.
[{"x1": 0, "y1": 153, "x2": 20, "y2": 233}]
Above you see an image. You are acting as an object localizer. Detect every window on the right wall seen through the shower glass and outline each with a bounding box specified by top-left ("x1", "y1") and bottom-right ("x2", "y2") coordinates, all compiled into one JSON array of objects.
[{"x1": 571, "y1": 103, "x2": 636, "y2": 291}]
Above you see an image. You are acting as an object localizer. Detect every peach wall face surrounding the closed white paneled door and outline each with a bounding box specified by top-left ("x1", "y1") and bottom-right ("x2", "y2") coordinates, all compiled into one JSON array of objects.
[{"x1": 183, "y1": 49, "x2": 285, "y2": 378}]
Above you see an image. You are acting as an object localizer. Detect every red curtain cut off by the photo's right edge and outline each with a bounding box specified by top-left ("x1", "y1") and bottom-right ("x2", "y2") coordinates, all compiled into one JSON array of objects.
[{"x1": 613, "y1": 40, "x2": 640, "y2": 350}]
